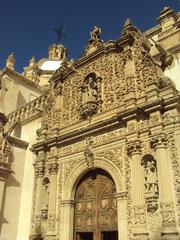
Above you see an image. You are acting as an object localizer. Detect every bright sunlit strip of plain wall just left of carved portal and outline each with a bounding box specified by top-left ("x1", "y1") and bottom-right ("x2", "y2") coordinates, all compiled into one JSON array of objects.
[{"x1": 14, "y1": 118, "x2": 41, "y2": 240}]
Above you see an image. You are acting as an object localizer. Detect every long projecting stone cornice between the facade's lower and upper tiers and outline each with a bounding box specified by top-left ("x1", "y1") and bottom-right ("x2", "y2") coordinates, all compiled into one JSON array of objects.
[{"x1": 31, "y1": 96, "x2": 180, "y2": 153}]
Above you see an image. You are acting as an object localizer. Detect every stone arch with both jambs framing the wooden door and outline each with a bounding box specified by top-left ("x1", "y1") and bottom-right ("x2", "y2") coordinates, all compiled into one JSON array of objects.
[{"x1": 61, "y1": 158, "x2": 128, "y2": 240}]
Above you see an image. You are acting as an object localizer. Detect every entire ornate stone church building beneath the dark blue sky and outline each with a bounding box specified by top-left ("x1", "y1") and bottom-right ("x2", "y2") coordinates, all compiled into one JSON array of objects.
[{"x1": 0, "y1": 7, "x2": 180, "y2": 240}]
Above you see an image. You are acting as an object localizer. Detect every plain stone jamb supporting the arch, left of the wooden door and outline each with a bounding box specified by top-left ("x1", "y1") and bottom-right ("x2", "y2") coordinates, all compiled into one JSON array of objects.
[{"x1": 61, "y1": 200, "x2": 75, "y2": 240}]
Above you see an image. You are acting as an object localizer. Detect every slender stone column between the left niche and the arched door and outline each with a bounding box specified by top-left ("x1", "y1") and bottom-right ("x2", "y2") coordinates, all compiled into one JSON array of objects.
[{"x1": 47, "y1": 158, "x2": 58, "y2": 235}]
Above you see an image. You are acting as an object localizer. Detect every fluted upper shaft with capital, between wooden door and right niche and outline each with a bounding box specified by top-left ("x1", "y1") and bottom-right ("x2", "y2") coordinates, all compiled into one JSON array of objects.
[{"x1": 127, "y1": 140, "x2": 145, "y2": 205}]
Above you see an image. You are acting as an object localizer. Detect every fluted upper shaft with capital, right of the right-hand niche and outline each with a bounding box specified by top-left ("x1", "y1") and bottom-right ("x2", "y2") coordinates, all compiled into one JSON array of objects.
[{"x1": 151, "y1": 133, "x2": 173, "y2": 202}]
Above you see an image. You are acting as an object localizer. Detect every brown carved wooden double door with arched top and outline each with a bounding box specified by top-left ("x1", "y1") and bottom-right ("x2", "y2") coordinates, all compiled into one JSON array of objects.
[{"x1": 74, "y1": 169, "x2": 118, "y2": 240}]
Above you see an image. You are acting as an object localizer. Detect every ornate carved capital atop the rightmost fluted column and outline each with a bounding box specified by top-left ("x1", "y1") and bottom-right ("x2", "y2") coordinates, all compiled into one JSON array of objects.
[{"x1": 150, "y1": 133, "x2": 168, "y2": 149}]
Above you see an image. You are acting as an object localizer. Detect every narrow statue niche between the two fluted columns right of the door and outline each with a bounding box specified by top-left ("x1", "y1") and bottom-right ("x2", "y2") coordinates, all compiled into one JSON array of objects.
[{"x1": 142, "y1": 154, "x2": 159, "y2": 213}]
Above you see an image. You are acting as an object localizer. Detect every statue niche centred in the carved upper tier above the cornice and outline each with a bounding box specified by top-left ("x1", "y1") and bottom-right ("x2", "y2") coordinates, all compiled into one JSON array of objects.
[{"x1": 80, "y1": 73, "x2": 101, "y2": 119}]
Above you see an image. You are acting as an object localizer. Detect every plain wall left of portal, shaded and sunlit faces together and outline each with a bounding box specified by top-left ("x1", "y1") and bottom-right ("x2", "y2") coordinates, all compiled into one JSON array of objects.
[{"x1": 0, "y1": 118, "x2": 41, "y2": 240}]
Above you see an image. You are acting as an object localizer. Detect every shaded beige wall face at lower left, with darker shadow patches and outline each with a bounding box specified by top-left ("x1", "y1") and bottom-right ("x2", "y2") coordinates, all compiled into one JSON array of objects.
[{"x1": 0, "y1": 147, "x2": 26, "y2": 240}]
